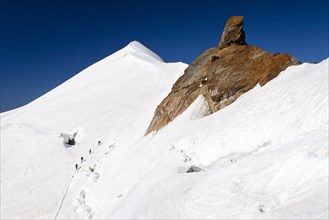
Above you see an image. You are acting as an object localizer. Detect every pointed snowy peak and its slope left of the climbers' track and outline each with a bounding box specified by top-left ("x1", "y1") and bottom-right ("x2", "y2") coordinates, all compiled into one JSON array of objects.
[{"x1": 1, "y1": 42, "x2": 186, "y2": 218}]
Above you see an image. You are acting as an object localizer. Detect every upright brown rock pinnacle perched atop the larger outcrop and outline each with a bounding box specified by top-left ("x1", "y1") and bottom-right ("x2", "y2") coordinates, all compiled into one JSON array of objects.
[{"x1": 218, "y1": 16, "x2": 247, "y2": 49}]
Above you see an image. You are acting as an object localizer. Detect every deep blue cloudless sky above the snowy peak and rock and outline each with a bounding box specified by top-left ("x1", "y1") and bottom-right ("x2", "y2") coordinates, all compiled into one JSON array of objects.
[{"x1": 0, "y1": 0, "x2": 329, "y2": 112}]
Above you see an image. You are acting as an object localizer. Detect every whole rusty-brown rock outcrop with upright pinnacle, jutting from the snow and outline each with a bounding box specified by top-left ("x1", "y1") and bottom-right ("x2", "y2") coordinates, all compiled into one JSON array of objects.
[{"x1": 146, "y1": 16, "x2": 299, "y2": 134}]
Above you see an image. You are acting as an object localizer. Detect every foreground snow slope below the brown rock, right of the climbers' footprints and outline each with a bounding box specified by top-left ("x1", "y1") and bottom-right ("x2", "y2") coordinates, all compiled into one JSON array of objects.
[{"x1": 86, "y1": 60, "x2": 328, "y2": 219}]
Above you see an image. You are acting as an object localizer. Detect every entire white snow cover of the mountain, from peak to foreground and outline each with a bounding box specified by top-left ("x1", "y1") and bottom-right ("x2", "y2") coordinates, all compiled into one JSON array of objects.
[{"x1": 1, "y1": 41, "x2": 329, "y2": 219}]
